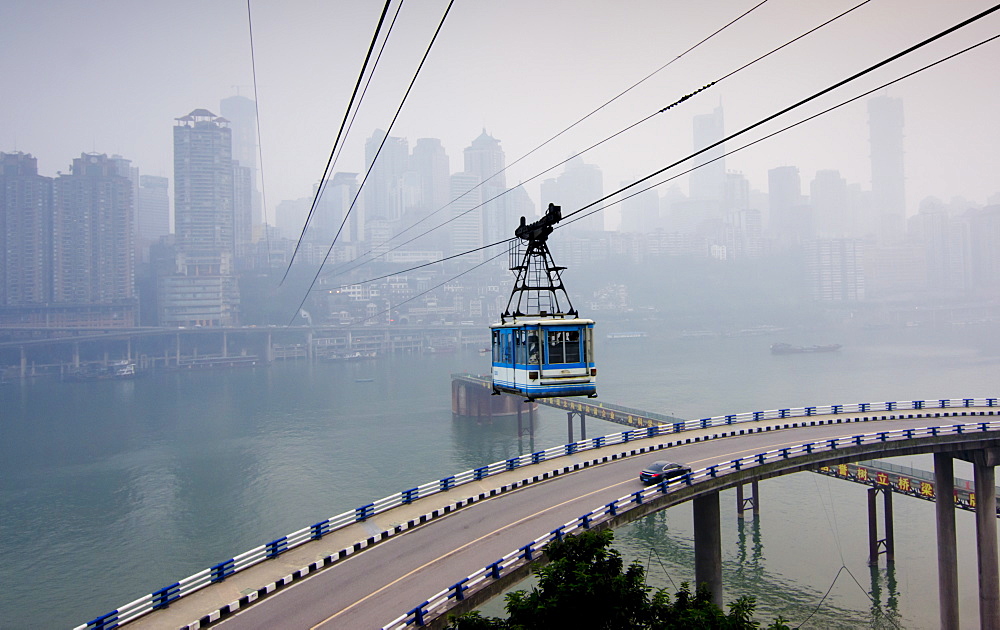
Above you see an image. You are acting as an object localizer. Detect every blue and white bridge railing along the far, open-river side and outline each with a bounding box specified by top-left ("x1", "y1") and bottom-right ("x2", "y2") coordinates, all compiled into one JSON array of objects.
[{"x1": 80, "y1": 398, "x2": 1000, "y2": 630}]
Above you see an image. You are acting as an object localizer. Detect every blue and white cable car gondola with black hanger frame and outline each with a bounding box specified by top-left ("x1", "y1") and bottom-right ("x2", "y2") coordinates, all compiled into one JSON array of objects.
[{"x1": 490, "y1": 204, "x2": 597, "y2": 400}]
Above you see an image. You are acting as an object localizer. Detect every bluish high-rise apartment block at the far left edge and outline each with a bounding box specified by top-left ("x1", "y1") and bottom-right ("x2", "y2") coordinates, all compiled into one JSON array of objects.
[{"x1": 0, "y1": 153, "x2": 52, "y2": 307}]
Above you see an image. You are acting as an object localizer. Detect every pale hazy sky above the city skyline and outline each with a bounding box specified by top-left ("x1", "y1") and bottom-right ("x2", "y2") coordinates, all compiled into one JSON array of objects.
[{"x1": 0, "y1": 0, "x2": 1000, "y2": 227}]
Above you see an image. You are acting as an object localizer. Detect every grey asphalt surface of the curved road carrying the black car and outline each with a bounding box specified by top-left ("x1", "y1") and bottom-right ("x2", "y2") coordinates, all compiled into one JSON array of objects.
[{"x1": 218, "y1": 417, "x2": 996, "y2": 630}]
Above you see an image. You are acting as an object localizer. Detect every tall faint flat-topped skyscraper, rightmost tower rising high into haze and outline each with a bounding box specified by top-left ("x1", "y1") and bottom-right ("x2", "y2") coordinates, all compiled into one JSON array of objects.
[{"x1": 868, "y1": 96, "x2": 906, "y2": 243}]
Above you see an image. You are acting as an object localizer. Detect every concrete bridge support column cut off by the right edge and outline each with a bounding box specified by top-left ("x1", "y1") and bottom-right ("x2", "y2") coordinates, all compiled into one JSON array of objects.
[{"x1": 973, "y1": 449, "x2": 1000, "y2": 630}]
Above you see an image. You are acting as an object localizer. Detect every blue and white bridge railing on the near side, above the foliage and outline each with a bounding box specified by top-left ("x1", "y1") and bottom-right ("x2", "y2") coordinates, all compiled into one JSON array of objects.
[{"x1": 383, "y1": 420, "x2": 1000, "y2": 630}]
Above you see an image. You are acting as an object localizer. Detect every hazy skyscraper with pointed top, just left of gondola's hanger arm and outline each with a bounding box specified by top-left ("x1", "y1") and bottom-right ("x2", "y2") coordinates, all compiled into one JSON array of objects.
[{"x1": 464, "y1": 129, "x2": 508, "y2": 243}]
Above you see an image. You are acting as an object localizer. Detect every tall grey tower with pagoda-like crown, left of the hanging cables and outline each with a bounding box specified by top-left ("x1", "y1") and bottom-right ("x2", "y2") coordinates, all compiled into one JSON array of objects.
[{"x1": 164, "y1": 109, "x2": 239, "y2": 326}]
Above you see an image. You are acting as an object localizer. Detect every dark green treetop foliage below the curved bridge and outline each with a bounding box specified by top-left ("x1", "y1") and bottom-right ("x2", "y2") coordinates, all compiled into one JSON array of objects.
[{"x1": 448, "y1": 530, "x2": 788, "y2": 630}]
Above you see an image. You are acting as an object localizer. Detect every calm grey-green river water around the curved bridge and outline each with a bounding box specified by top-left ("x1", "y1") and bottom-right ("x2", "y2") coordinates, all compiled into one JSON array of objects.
[{"x1": 0, "y1": 324, "x2": 1000, "y2": 629}]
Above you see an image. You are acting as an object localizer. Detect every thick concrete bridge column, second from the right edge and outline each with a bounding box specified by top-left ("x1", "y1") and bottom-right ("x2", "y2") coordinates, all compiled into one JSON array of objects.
[{"x1": 934, "y1": 453, "x2": 959, "y2": 630}]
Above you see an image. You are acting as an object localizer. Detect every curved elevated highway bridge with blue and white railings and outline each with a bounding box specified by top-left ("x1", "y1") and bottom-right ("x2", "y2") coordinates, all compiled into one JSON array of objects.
[{"x1": 80, "y1": 398, "x2": 1000, "y2": 628}]
